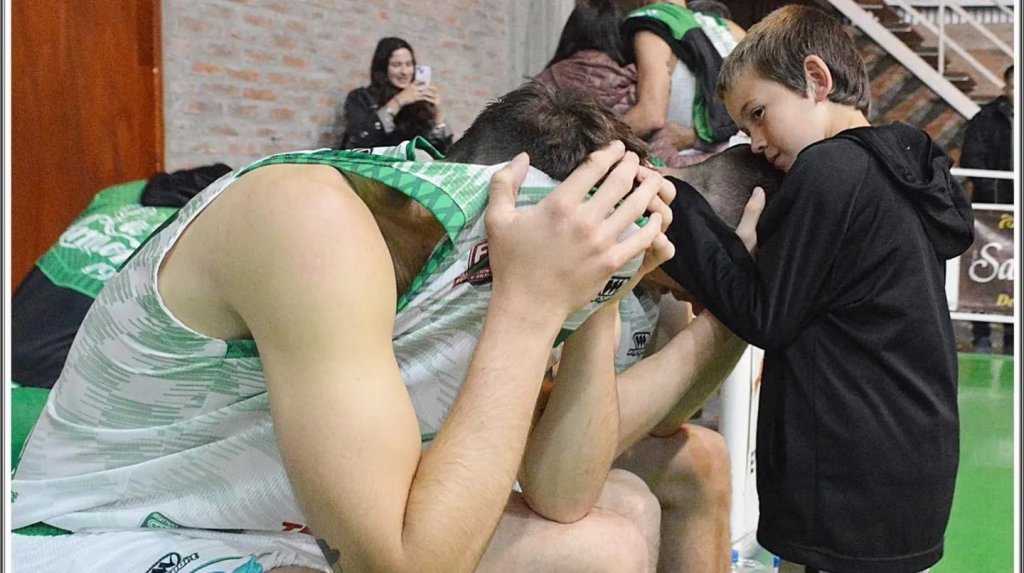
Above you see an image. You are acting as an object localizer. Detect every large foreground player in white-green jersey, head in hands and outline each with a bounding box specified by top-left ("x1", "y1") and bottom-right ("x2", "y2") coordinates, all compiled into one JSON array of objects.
[{"x1": 12, "y1": 82, "x2": 672, "y2": 571}]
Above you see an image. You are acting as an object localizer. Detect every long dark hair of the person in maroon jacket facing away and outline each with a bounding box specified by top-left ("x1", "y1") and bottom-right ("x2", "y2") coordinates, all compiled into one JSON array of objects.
[{"x1": 547, "y1": 0, "x2": 629, "y2": 68}]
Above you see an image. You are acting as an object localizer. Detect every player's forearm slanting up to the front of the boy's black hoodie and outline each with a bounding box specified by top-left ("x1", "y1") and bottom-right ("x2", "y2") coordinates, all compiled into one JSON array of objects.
[{"x1": 618, "y1": 312, "x2": 746, "y2": 453}]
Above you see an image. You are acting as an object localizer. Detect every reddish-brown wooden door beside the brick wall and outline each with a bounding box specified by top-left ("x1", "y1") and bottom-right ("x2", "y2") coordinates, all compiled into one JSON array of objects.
[{"x1": 10, "y1": 0, "x2": 163, "y2": 288}]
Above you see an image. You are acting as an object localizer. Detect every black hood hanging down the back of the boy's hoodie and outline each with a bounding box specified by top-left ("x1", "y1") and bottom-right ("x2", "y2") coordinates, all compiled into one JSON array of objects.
[{"x1": 837, "y1": 123, "x2": 974, "y2": 259}]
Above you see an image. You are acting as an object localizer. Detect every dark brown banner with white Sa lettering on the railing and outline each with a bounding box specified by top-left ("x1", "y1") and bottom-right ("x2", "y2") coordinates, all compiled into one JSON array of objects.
[{"x1": 956, "y1": 209, "x2": 1017, "y2": 315}]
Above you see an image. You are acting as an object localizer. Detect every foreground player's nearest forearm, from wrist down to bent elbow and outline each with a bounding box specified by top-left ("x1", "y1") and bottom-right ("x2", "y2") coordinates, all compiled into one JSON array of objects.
[{"x1": 402, "y1": 301, "x2": 560, "y2": 571}]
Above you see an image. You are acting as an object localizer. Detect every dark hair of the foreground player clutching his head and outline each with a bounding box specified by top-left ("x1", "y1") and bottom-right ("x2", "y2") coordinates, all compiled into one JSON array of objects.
[{"x1": 444, "y1": 81, "x2": 648, "y2": 181}]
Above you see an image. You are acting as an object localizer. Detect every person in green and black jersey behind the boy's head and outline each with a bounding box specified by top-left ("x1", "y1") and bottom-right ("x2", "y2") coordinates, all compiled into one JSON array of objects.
[{"x1": 623, "y1": 0, "x2": 736, "y2": 167}]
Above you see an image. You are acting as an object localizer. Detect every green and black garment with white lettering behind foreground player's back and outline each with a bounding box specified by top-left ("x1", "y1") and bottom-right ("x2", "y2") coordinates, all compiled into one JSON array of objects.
[{"x1": 10, "y1": 164, "x2": 230, "y2": 388}]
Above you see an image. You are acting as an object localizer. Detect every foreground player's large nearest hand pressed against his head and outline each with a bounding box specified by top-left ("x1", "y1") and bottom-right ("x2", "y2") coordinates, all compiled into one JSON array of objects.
[{"x1": 484, "y1": 141, "x2": 668, "y2": 320}]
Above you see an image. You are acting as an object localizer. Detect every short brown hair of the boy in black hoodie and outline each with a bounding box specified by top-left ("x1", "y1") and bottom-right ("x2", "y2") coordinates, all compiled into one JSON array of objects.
[{"x1": 718, "y1": 4, "x2": 871, "y2": 115}]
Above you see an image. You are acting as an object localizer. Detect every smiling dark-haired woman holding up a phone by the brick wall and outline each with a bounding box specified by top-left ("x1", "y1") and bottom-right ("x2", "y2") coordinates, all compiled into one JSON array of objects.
[{"x1": 341, "y1": 38, "x2": 452, "y2": 153}]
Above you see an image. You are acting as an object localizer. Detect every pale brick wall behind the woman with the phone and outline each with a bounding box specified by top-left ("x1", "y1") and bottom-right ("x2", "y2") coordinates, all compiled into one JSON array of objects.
[{"x1": 162, "y1": 0, "x2": 515, "y2": 171}]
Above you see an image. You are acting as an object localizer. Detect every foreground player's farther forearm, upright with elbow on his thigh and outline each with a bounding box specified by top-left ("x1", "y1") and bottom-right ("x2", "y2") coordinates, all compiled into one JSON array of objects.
[{"x1": 520, "y1": 306, "x2": 618, "y2": 523}]
